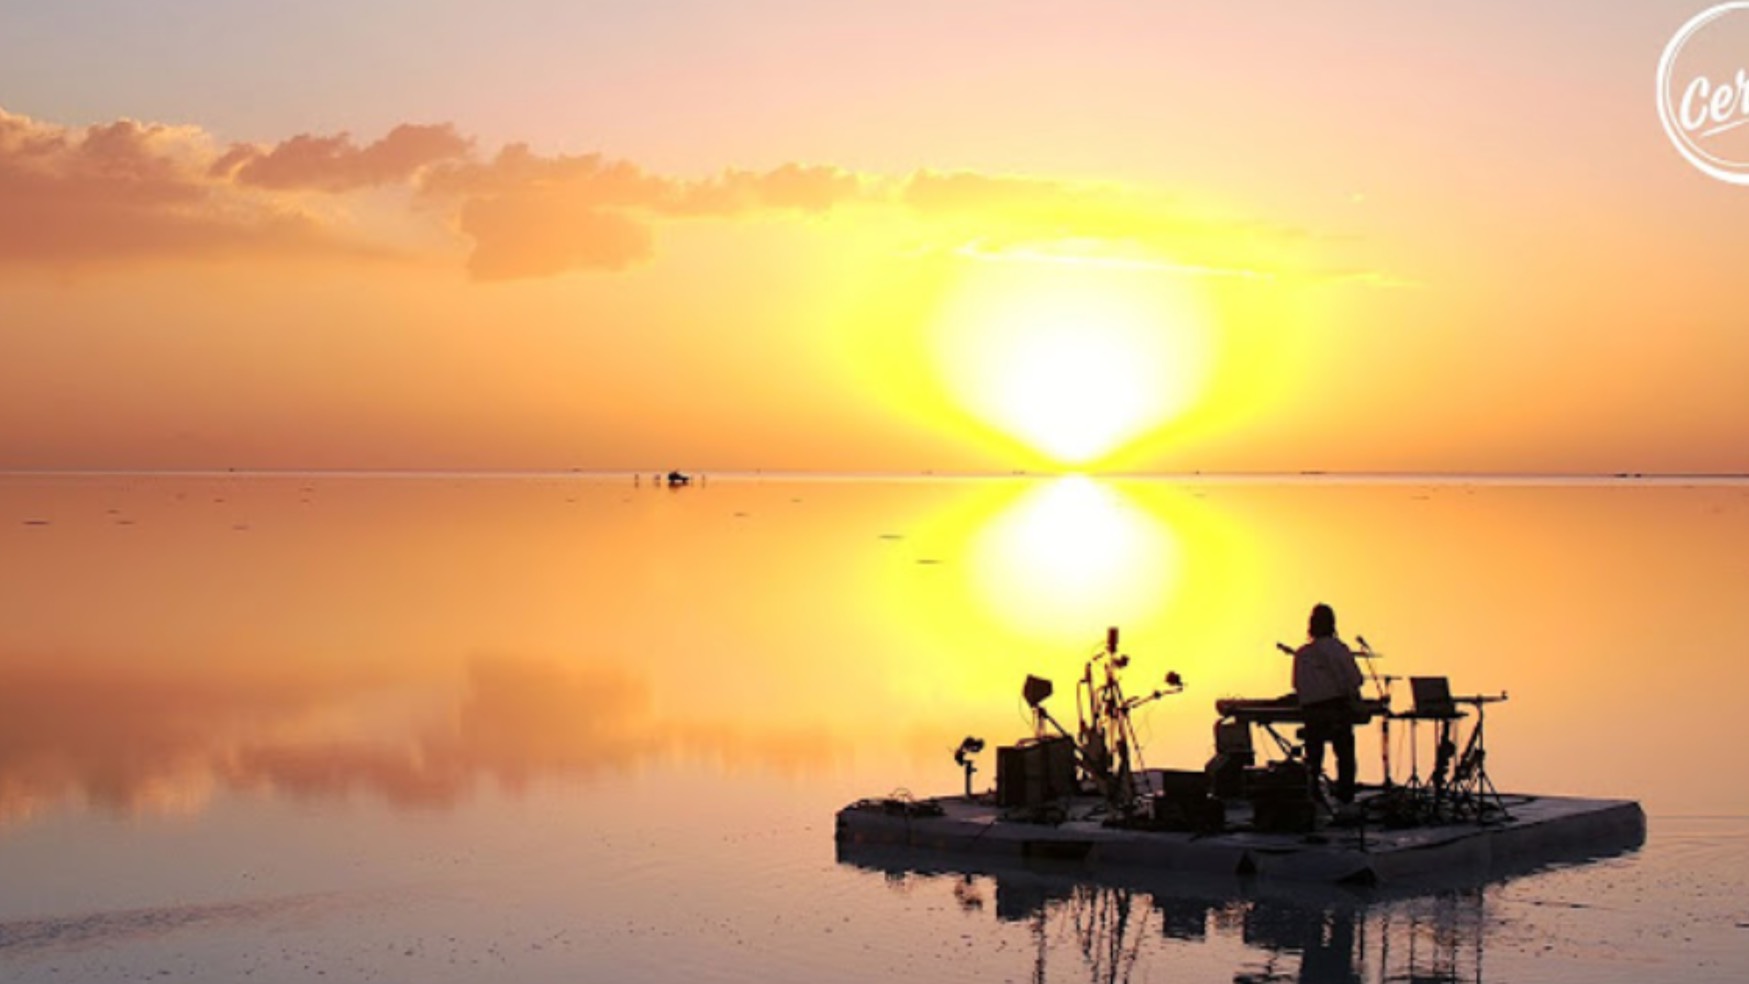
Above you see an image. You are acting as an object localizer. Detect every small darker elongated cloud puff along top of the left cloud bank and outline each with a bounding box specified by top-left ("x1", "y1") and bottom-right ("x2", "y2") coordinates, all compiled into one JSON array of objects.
[{"x1": 208, "y1": 124, "x2": 474, "y2": 192}]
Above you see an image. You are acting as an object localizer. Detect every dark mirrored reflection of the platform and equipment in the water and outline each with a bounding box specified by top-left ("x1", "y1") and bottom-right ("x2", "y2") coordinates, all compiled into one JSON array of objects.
[{"x1": 838, "y1": 841, "x2": 1546, "y2": 984}]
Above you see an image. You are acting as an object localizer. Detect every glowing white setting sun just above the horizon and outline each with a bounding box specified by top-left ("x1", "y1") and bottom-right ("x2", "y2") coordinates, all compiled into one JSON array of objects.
[{"x1": 936, "y1": 259, "x2": 1210, "y2": 467}]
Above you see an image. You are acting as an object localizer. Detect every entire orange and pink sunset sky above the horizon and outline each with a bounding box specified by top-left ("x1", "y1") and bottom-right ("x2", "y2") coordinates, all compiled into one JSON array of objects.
[{"x1": 0, "y1": 0, "x2": 1749, "y2": 472}]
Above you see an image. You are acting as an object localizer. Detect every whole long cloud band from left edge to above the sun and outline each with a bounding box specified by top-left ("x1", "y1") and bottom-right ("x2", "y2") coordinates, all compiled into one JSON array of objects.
[{"x1": 0, "y1": 110, "x2": 1397, "y2": 285}]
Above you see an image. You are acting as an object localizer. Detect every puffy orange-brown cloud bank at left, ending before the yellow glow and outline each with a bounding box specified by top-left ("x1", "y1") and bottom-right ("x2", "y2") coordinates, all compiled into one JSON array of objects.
[{"x1": 0, "y1": 110, "x2": 868, "y2": 280}]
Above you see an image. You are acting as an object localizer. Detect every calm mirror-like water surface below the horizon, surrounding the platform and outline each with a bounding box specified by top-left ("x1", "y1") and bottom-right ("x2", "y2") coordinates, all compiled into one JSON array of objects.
[{"x1": 0, "y1": 475, "x2": 1749, "y2": 981}]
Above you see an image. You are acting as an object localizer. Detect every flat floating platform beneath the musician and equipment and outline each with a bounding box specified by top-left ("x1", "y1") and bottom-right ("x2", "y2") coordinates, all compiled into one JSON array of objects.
[{"x1": 838, "y1": 795, "x2": 1646, "y2": 884}]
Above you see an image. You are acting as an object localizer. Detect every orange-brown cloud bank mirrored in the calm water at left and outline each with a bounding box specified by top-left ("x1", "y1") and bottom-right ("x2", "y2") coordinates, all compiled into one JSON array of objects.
[{"x1": 0, "y1": 657, "x2": 843, "y2": 821}]
